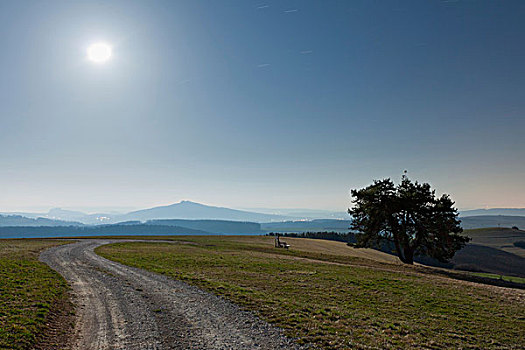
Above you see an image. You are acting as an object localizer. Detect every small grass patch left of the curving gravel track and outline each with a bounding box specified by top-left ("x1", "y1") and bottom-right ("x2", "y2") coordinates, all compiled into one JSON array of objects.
[{"x1": 0, "y1": 240, "x2": 67, "y2": 349}]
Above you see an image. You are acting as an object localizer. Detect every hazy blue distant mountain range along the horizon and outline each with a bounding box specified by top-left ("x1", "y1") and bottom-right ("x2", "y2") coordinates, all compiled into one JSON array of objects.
[{"x1": 0, "y1": 201, "x2": 525, "y2": 233}]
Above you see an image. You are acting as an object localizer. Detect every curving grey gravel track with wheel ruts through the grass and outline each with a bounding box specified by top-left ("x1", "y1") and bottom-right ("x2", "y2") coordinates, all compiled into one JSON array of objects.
[{"x1": 40, "y1": 240, "x2": 300, "y2": 350}]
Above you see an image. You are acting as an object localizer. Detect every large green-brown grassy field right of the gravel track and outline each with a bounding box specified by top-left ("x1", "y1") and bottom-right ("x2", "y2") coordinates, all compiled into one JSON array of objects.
[{"x1": 97, "y1": 236, "x2": 525, "y2": 349}]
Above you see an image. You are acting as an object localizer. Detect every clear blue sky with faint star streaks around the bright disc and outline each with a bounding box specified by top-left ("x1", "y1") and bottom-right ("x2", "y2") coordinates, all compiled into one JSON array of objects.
[{"x1": 0, "y1": 0, "x2": 525, "y2": 211}]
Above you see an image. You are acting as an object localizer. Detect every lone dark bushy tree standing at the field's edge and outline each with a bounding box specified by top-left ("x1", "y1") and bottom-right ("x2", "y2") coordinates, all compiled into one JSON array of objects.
[{"x1": 348, "y1": 175, "x2": 470, "y2": 264}]
